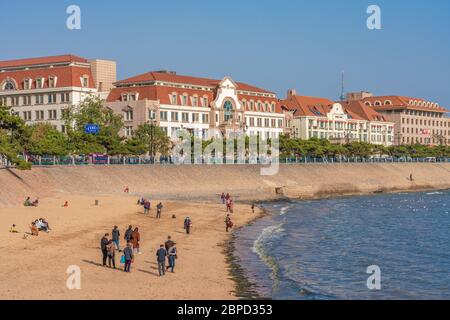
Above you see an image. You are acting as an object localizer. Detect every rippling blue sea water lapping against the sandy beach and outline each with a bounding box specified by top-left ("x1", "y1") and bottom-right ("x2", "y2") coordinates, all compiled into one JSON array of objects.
[{"x1": 234, "y1": 191, "x2": 450, "y2": 299}]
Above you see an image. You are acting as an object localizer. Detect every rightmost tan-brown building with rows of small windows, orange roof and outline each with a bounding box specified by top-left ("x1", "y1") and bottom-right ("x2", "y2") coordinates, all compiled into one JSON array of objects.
[{"x1": 348, "y1": 95, "x2": 450, "y2": 145}]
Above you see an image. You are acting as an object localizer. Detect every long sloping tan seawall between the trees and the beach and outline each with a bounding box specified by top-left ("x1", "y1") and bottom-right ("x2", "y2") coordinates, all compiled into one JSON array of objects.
[{"x1": 0, "y1": 163, "x2": 450, "y2": 206}]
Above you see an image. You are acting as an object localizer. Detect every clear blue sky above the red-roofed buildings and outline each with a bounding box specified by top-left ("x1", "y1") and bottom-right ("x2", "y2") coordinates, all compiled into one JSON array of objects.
[{"x1": 0, "y1": 0, "x2": 450, "y2": 108}]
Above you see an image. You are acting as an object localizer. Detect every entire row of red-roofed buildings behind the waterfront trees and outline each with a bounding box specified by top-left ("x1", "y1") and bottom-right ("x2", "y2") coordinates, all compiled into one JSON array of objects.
[{"x1": 0, "y1": 55, "x2": 450, "y2": 146}]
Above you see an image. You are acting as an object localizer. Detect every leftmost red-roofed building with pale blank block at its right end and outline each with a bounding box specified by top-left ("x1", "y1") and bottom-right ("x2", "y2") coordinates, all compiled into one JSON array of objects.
[{"x1": 0, "y1": 55, "x2": 116, "y2": 131}]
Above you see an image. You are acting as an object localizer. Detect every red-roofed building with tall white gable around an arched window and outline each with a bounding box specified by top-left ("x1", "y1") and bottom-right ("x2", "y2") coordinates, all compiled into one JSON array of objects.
[{"x1": 106, "y1": 71, "x2": 284, "y2": 139}]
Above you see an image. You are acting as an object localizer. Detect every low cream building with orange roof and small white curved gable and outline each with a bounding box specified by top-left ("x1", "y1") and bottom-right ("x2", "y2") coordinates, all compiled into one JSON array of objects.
[{"x1": 280, "y1": 90, "x2": 394, "y2": 146}]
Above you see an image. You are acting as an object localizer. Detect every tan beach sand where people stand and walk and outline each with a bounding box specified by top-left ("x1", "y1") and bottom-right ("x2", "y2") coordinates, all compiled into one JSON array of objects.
[{"x1": 0, "y1": 195, "x2": 261, "y2": 300}]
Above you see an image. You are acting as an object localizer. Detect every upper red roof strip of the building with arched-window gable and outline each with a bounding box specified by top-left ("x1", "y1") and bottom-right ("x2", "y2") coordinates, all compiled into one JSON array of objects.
[{"x1": 115, "y1": 72, "x2": 274, "y2": 94}]
